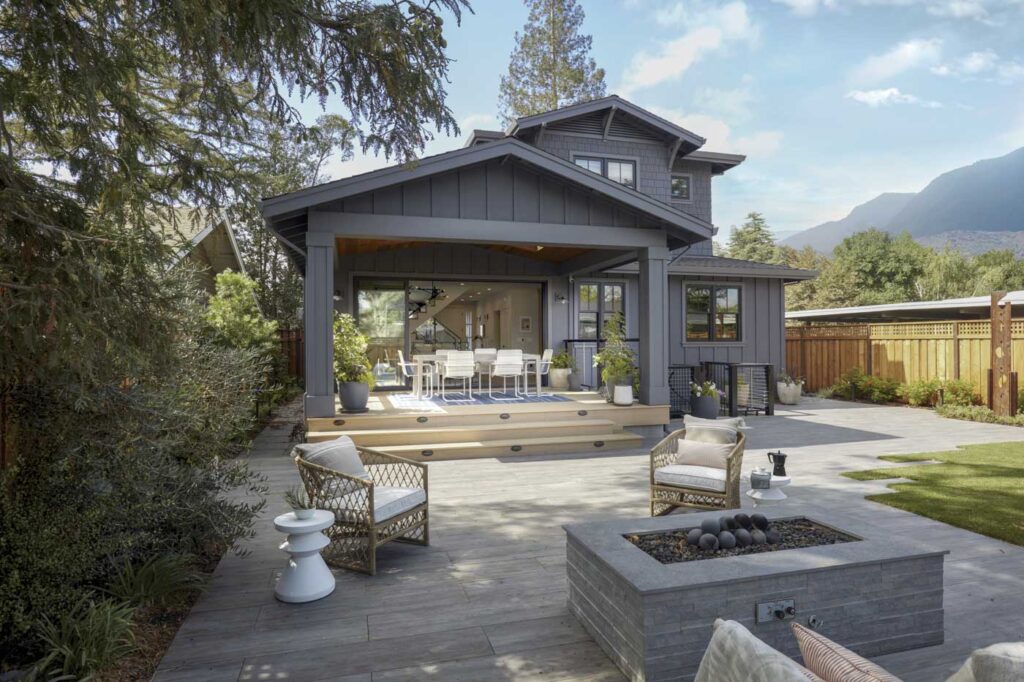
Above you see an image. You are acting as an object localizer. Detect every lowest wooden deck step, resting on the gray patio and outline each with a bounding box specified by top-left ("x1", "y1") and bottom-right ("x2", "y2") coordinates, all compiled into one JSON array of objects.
[{"x1": 368, "y1": 432, "x2": 643, "y2": 462}]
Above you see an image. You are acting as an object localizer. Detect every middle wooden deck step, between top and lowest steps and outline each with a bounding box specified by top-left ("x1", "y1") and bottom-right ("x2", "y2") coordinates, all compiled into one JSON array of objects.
[{"x1": 306, "y1": 419, "x2": 617, "y2": 447}]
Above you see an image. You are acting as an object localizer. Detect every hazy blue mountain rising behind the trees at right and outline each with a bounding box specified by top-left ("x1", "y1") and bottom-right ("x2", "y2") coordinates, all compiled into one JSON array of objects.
[{"x1": 783, "y1": 147, "x2": 1024, "y2": 253}]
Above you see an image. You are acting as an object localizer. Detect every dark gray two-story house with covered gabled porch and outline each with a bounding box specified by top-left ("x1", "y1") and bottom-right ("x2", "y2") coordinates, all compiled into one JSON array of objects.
[{"x1": 263, "y1": 96, "x2": 814, "y2": 417}]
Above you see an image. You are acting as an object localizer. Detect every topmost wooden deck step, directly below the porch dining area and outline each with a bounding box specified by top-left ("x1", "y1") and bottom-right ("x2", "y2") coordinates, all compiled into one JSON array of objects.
[{"x1": 306, "y1": 400, "x2": 669, "y2": 433}]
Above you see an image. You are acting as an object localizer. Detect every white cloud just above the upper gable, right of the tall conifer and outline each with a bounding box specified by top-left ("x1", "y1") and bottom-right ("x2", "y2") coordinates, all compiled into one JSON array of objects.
[{"x1": 618, "y1": 0, "x2": 758, "y2": 97}]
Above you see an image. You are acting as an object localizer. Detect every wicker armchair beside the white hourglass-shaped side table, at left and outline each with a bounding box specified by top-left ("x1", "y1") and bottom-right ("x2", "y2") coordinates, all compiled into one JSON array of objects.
[{"x1": 295, "y1": 447, "x2": 430, "y2": 576}]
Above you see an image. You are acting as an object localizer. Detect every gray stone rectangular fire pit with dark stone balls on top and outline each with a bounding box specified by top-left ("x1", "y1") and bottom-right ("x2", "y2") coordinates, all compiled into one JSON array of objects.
[{"x1": 564, "y1": 507, "x2": 947, "y2": 681}]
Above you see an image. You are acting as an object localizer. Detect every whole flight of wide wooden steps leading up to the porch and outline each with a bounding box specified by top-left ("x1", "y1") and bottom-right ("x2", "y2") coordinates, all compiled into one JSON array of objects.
[{"x1": 306, "y1": 401, "x2": 669, "y2": 461}]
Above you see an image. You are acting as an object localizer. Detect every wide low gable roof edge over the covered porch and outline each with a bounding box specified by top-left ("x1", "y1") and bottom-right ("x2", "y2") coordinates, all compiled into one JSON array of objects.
[{"x1": 262, "y1": 137, "x2": 715, "y2": 266}]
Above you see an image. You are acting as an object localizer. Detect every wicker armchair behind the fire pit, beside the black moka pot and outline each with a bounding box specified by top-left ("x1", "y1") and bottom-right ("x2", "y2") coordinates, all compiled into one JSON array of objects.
[{"x1": 650, "y1": 429, "x2": 746, "y2": 516}]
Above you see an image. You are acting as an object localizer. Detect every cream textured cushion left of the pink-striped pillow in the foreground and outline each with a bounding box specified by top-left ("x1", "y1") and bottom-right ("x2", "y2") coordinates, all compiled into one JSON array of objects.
[{"x1": 693, "y1": 619, "x2": 821, "y2": 682}]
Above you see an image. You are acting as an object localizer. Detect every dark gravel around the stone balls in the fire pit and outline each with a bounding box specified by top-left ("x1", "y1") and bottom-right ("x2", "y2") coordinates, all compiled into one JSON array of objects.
[{"x1": 625, "y1": 519, "x2": 857, "y2": 563}]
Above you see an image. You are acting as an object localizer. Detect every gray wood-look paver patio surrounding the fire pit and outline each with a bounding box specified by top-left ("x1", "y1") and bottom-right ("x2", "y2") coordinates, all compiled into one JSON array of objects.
[{"x1": 154, "y1": 398, "x2": 1024, "y2": 682}]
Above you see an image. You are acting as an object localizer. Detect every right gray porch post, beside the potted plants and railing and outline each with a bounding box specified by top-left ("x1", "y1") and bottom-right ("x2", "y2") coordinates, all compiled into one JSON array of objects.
[{"x1": 637, "y1": 247, "x2": 670, "y2": 404}]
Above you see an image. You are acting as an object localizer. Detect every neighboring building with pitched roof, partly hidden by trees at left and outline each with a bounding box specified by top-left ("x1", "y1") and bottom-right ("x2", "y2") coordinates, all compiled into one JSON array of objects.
[{"x1": 153, "y1": 208, "x2": 245, "y2": 294}]
